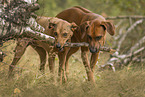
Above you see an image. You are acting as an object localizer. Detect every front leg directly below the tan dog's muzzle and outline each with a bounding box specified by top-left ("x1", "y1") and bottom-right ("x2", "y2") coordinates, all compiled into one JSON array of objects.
[{"x1": 58, "y1": 50, "x2": 68, "y2": 84}]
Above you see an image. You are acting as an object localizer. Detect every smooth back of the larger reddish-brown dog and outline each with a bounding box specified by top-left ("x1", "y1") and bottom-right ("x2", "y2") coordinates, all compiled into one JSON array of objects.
[{"x1": 56, "y1": 6, "x2": 105, "y2": 25}]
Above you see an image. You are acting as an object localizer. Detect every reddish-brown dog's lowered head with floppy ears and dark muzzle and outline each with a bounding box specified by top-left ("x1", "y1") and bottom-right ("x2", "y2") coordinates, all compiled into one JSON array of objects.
[{"x1": 80, "y1": 19, "x2": 115, "y2": 53}]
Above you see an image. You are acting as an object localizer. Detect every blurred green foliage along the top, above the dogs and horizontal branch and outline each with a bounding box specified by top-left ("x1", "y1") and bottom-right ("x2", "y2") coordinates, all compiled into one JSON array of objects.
[{"x1": 37, "y1": 0, "x2": 145, "y2": 16}]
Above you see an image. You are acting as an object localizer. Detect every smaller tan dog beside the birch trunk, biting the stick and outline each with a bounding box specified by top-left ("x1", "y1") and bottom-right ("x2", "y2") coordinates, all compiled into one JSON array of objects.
[{"x1": 9, "y1": 17, "x2": 77, "y2": 77}]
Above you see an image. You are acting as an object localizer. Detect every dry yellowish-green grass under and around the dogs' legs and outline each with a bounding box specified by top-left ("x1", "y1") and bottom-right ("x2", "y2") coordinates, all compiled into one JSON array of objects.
[{"x1": 0, "y1": 41, "x2": 145, "y2": 97}]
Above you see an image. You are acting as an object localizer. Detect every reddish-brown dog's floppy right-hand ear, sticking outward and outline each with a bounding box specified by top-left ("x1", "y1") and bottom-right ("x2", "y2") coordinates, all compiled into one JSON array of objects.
[{"x1": 101, "y1": 21, "x2": 115, "y2": 36}]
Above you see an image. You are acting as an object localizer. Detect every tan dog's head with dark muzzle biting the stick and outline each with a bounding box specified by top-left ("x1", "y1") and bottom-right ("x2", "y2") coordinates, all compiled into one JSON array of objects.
[{"x1": 38, "y1": 17, "x2": 77, "y2": 51}]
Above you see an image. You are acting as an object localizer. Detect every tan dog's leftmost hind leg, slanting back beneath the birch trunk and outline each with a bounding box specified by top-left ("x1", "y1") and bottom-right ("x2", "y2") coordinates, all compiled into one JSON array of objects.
[{"x1": 8, "y1": 39, "x2": 29, "y2": 78}]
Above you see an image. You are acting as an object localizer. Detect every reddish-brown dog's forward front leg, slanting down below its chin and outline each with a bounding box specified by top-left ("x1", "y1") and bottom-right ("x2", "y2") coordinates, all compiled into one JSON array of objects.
[{"x1": 81, "y1": 47, "x2": 95, "y2": 82}]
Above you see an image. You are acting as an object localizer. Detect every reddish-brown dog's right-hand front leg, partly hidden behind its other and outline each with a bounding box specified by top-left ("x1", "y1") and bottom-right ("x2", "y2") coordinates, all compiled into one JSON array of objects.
[{"x1": 90, "y1": 53, "x2": 99, "y2": 72}]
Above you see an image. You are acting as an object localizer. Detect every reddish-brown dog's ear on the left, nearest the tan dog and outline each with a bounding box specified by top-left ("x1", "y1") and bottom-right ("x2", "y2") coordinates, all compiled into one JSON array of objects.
[{"x1": 80, "y1": 21, "x2": 90, "y2": 39}]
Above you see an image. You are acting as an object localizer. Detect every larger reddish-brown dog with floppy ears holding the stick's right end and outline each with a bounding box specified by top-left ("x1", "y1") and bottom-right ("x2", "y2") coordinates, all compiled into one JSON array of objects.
[{"x1": 56, "y1": 6, "x2": 115, "y2": 82}]
